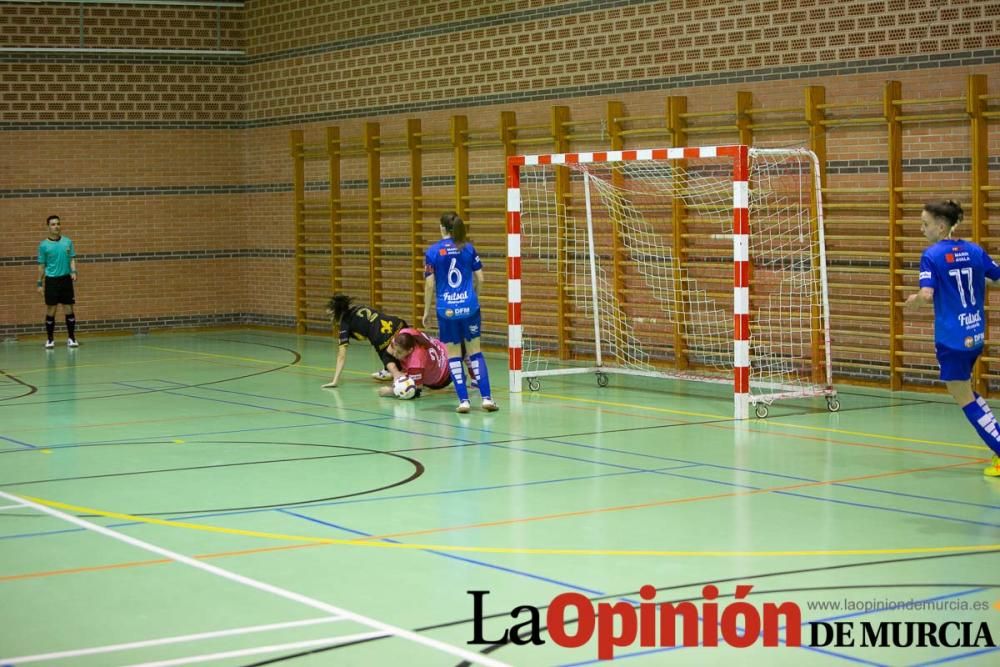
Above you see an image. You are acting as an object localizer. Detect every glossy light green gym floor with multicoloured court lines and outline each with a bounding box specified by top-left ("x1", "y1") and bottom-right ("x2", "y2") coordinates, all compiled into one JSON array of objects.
[{"x1": 0, "y1": 329, "x2": 1000, "y2": 667}]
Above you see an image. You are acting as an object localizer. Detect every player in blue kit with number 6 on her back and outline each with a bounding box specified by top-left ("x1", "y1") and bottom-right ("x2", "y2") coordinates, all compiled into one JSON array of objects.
[{"x1": 422, "y1": 212, "x2": 500, "y2": 413}]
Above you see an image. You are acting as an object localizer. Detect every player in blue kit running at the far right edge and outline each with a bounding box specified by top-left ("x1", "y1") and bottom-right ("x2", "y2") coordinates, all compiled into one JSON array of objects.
[{"x1": 906, "y1": 200, "x2": 1000, "y2": 477}]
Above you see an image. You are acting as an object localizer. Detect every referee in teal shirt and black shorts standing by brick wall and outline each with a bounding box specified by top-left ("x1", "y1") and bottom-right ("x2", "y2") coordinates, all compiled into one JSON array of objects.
[{"x1": 36, "y1": 215, "x2": 78, "y2": 350}]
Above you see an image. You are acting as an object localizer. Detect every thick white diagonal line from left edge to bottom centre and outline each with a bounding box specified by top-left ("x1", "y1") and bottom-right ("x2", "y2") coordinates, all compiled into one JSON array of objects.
[{"x1": 0, "y1": 491, "x2": 510, "y2": 667}]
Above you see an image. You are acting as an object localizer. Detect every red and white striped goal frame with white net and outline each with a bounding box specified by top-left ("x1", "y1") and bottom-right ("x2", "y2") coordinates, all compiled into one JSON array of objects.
[{"x1": 507, "y1": 145, "x2": 840, "y2": 419}]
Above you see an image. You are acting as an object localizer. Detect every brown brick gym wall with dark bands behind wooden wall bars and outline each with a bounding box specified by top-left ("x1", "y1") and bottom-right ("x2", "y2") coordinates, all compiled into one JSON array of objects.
[{"x1": 0, "y1": 0, "x2": 1000, "y2": 392}]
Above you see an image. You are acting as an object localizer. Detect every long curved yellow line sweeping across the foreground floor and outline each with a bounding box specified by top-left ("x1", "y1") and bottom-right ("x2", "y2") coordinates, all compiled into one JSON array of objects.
[{"x1": 10, "y1": 494, "x2": 1000, "y2": 558}]
